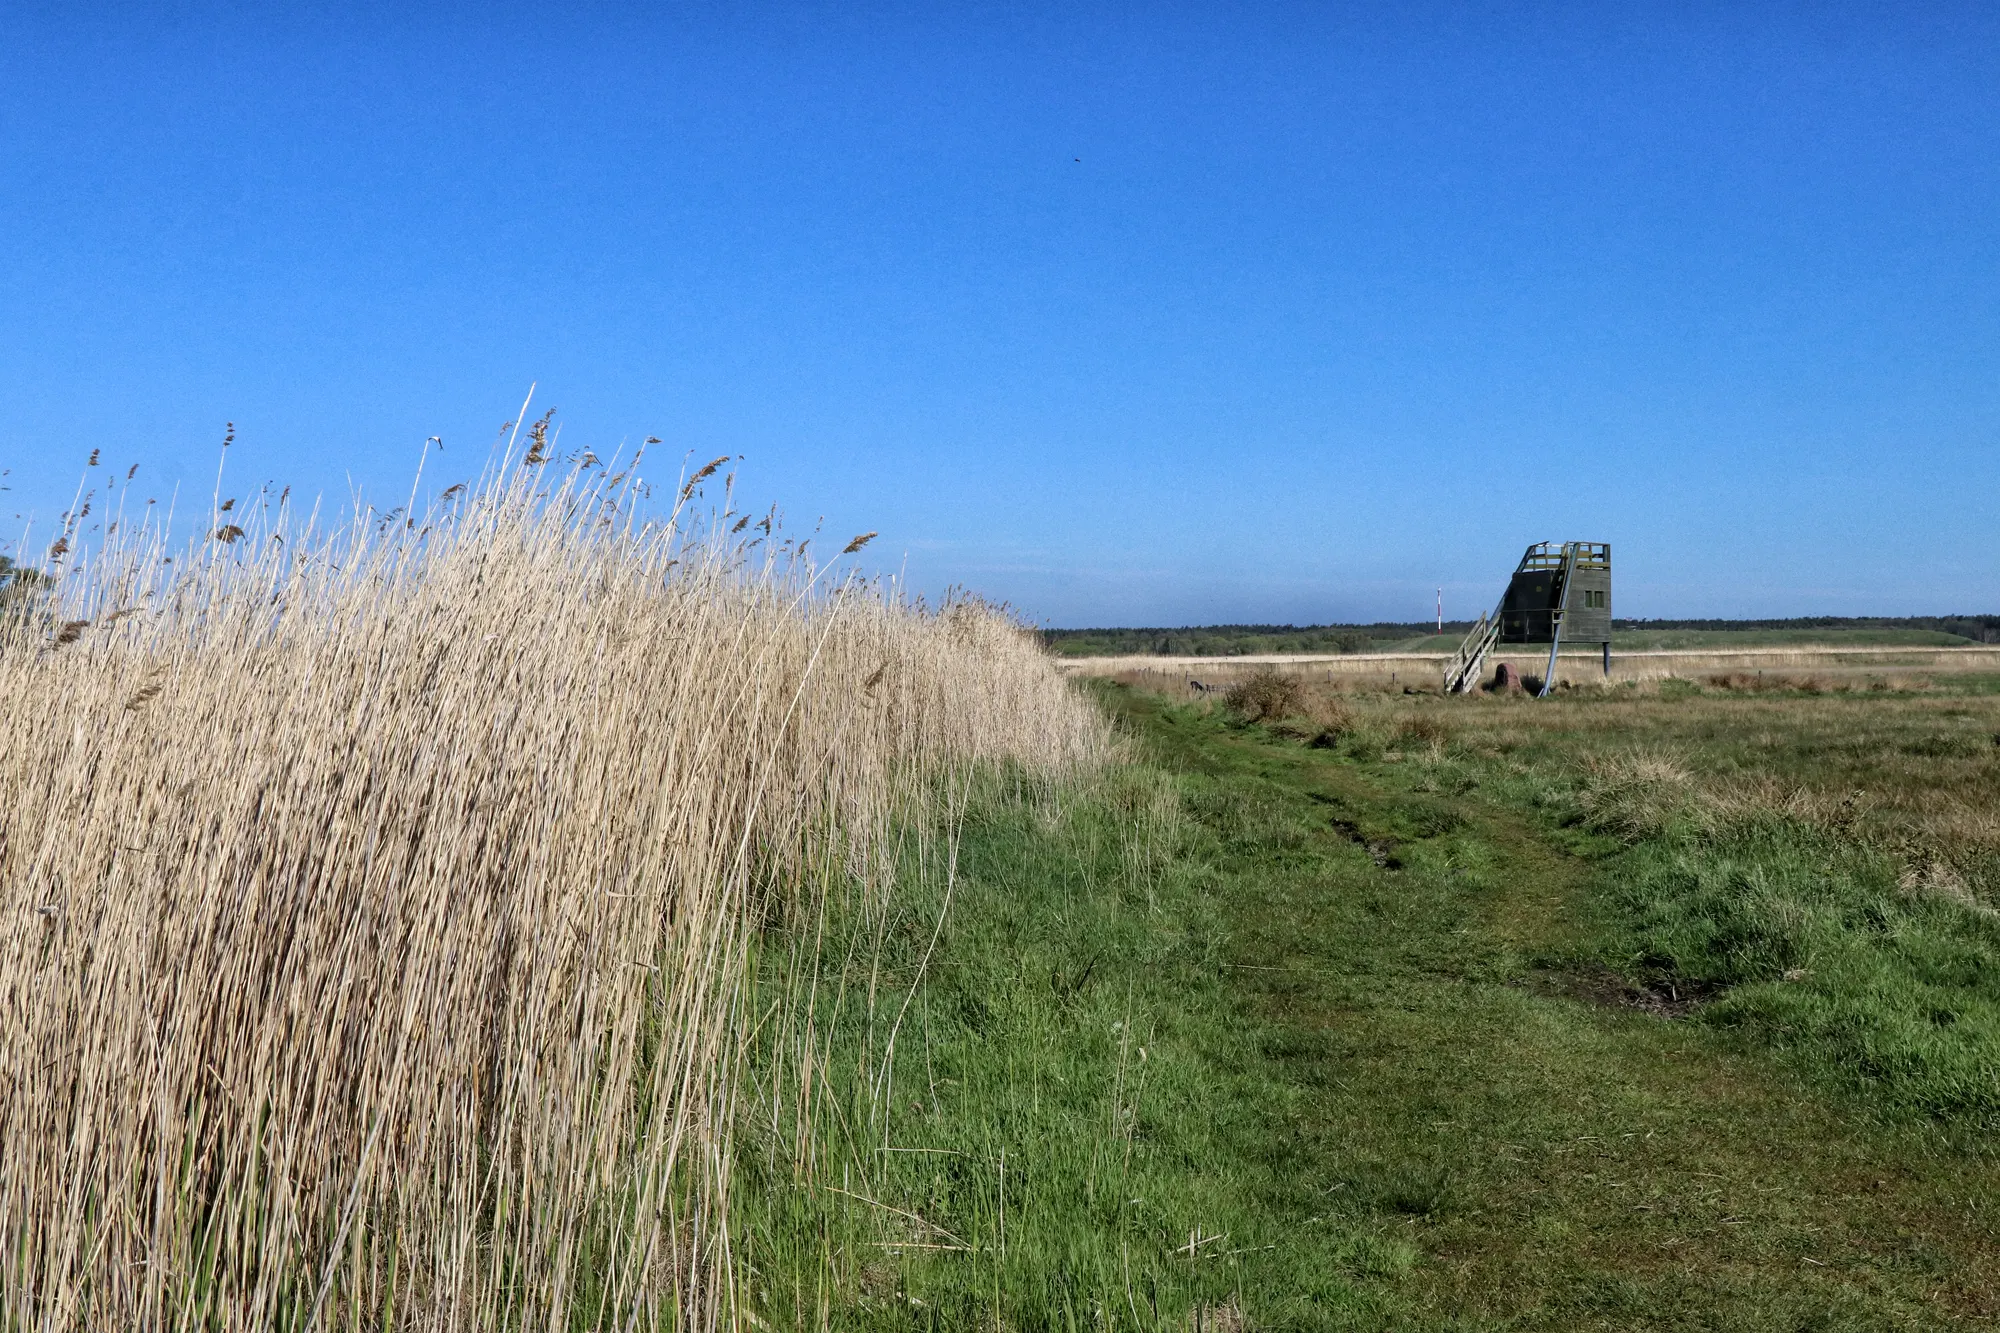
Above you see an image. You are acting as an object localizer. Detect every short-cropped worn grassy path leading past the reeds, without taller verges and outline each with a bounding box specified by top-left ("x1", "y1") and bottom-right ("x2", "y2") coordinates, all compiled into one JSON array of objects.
[{"x1": 1124, "y1": 697, "x2": 2000, "y2": 1329}]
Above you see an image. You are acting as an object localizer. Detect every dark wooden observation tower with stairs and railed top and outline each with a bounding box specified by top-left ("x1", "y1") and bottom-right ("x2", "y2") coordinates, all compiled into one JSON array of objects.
[{"x1": 1444, "y1": 542, "x2": 1612, "y2": 695}]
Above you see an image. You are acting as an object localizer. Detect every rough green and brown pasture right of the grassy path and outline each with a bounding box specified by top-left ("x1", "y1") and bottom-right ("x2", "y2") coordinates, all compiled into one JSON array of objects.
[{"x1": 1424, "y1": 677, "x2": 2000, "y2": 1131}]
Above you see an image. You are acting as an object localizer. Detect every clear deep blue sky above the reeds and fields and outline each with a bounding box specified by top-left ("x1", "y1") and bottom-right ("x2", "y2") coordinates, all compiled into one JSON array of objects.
[{"x1": 0, "y1": 2, "x2": 2000, "y2": 624}]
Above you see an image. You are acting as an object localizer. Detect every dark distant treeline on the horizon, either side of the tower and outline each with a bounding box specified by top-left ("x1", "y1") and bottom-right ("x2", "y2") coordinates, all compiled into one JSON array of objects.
[{"x1": 1042, "y1": 614, "x2": 2000, "y2": 656}]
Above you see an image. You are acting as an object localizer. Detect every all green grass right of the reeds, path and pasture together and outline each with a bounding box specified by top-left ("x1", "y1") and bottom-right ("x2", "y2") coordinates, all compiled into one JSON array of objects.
[{"x1": 738, "y1": 687, "x2": 2000, "y2": 1329}]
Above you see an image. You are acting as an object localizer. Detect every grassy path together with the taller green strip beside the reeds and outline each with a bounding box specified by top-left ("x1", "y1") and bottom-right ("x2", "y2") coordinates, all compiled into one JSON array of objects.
[{"x1": 744, "y1": 691, "x2": 2000, "y2": 1331}]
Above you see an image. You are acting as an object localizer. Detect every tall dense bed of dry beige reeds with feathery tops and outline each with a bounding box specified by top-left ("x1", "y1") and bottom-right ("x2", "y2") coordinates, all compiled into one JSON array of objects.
[{"x1": 0, "y1": 452, "x2": 1106, "y2": 1329}]
